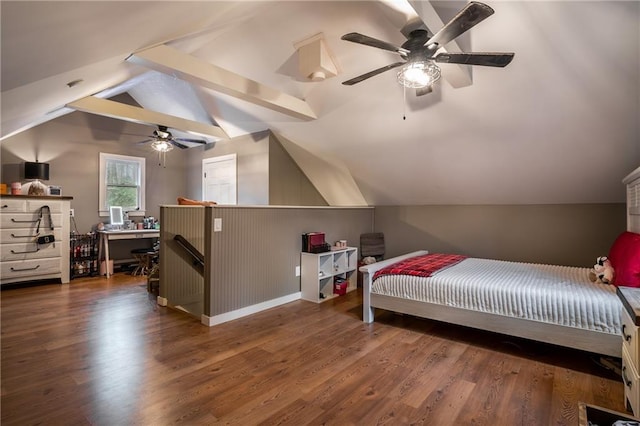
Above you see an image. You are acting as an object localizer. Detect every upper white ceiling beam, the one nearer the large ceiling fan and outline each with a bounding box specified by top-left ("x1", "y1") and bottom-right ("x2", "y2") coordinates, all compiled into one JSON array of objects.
[{"x1": 127, "y1": 44, "x2": 317, "y2": 120}]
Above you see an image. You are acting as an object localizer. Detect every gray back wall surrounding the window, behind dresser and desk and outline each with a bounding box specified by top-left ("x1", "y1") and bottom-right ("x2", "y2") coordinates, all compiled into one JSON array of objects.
[{"x1": 0, "y1": 112, "x2": 186, "y2": 259}]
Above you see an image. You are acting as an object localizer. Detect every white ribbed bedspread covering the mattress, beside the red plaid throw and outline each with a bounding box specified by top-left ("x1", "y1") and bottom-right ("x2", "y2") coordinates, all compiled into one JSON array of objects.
[{"x1": 371, "y1": 258, "x2": 622, "y2": 334}]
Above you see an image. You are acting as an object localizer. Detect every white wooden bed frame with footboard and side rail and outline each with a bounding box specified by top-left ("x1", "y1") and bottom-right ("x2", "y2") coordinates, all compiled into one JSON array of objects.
[{"x1": 360, "y1": 167, "x2": 640, "y2": 358}]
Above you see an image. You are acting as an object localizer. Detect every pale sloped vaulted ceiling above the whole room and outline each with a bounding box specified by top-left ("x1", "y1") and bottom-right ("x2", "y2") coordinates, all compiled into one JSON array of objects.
[{"x1": 0, "y1": 1, "x2": 640, "y2": 205}]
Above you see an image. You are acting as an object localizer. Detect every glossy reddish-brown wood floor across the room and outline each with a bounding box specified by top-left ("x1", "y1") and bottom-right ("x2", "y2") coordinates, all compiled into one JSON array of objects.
[{"x1": 0, "y1": 274, "x2": 625, "y2": 426}]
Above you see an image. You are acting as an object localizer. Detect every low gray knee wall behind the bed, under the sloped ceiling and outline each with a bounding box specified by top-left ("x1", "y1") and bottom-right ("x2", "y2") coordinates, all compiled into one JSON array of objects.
[{"x1": 375, "y1": 204, "x2": 626, "y2": 267}]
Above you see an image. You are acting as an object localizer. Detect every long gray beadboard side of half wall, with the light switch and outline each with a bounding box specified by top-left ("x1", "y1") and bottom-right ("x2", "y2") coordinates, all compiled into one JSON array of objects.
[{"x1": 204, "y1": 206, "x2": 374, "y2": 317}]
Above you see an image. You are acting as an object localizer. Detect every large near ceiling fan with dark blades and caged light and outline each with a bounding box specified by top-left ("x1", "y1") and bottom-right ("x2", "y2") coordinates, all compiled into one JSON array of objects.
[{"x1": 342, "y1": 1, "x2": 514, "y2": 96}]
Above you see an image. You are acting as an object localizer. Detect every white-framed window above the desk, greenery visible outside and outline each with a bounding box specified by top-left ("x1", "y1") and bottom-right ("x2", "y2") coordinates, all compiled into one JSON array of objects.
[{"x1": 99, "y1": 152, "x2": 145, "y2": 216}]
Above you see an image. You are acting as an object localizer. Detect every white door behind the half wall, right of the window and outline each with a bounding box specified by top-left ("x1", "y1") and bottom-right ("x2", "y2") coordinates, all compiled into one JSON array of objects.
[{"x1": 202, "y1": 154, "x2": 238, "y2": 204}]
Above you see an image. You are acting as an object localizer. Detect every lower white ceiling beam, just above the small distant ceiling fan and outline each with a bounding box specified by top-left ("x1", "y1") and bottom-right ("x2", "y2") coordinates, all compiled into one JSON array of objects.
[{"x1": 66, "y1": 96, "x2": 229, "y2": 139}]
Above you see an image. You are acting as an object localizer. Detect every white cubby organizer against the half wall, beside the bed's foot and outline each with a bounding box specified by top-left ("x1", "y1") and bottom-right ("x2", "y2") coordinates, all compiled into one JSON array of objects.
[{"x1": 300, "y1": 247, "x2": 358, "y2": 303}]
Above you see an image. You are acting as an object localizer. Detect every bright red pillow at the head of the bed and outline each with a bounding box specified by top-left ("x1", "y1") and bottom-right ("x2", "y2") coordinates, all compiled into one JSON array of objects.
[{"x1": 609, "y1": 231, "x2": 640, "y2": 287}]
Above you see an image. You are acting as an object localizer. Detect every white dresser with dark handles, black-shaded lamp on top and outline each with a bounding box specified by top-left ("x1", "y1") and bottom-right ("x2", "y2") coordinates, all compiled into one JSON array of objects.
[{"x1": 0, "y1": 195, "x2": 72, "y2": 284}]
